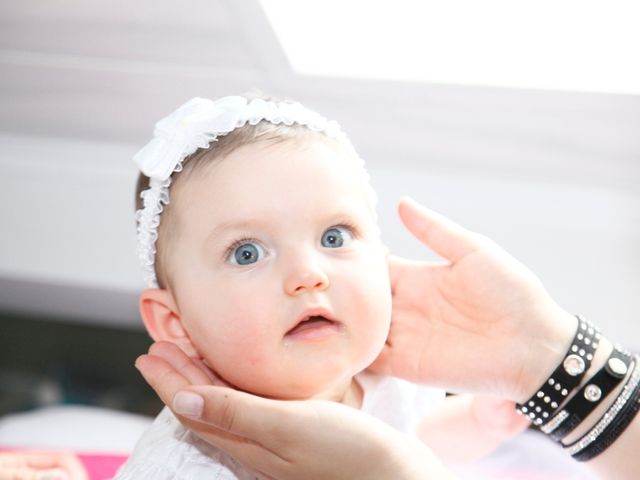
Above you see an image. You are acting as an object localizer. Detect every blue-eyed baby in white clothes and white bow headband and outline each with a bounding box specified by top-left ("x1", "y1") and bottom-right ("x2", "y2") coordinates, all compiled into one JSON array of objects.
[{"x1": 117, "y1": 96, "x2": 528, "y2": 479}]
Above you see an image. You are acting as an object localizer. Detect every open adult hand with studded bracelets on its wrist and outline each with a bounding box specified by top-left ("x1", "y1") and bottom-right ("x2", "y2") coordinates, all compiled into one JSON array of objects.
[{"x1": 371, "y1": 199, "x2": 577, "y2": 401}]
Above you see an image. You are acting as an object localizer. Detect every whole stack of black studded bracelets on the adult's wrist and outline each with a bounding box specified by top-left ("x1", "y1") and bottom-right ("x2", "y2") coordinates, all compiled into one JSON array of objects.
[{"x1": 516, "y1": 315, "x2": 640, "y2": 461}]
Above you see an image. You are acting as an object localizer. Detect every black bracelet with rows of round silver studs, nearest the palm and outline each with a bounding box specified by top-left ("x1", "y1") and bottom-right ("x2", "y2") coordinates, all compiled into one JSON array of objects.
[{"x1": 516, "y1": 315, "x2": 601, "y2": 427}]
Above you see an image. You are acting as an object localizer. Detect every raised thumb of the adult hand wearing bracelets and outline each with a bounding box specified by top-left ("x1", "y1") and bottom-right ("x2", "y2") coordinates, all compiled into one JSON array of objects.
[{"x1": 398, "y1": 197, "x2": 483, "y2": 263}]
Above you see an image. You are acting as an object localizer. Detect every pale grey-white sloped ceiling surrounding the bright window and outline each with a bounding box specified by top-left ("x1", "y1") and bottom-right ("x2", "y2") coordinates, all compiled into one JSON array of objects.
[{"x1": 0, "y1": 0, "x2": 640, "y2": 187}]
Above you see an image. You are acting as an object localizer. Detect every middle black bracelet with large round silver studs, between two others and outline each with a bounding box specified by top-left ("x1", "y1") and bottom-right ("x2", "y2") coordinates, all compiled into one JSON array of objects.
[{"x1": 540, "y1": 347, "x2": 632, "y2": 441}]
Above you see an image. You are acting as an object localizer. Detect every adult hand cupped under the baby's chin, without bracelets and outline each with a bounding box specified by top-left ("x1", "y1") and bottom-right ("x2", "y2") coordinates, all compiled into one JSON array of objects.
[{"x1": 136, "y1": 342, "x2": 453, "y2": 480}]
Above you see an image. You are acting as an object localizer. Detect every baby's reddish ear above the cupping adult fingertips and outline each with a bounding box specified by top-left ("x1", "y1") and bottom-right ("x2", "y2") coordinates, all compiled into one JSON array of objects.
[{"x1": 139, "y1": 288, "x2": 198, "y2": 357}]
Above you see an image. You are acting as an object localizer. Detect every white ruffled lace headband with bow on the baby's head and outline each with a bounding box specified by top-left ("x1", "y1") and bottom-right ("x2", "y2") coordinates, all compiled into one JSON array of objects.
[{"x1": 133, "y1": 96, "x2": 357, "y2": 288}]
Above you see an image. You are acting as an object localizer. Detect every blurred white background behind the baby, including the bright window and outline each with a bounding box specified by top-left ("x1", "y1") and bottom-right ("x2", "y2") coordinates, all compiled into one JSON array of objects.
[{"x1": 0, "y1": 0, "x2": 640, "y2": 346}]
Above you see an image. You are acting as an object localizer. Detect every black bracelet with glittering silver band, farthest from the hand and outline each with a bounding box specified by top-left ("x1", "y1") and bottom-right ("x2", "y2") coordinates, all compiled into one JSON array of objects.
[{"x1": 565, "y1": 355, "x2": 640, "y2": 461}]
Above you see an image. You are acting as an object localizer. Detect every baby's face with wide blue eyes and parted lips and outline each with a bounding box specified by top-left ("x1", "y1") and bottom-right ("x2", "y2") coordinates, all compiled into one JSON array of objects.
[{"x1": 172, "y1": 140, "x2": 391, "y2": 398}]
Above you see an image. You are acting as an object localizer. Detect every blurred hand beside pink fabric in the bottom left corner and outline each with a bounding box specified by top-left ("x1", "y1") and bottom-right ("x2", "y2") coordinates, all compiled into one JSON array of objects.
[{"x1": 0, "y1": 451, "x2": 89, "y2": 480}]
